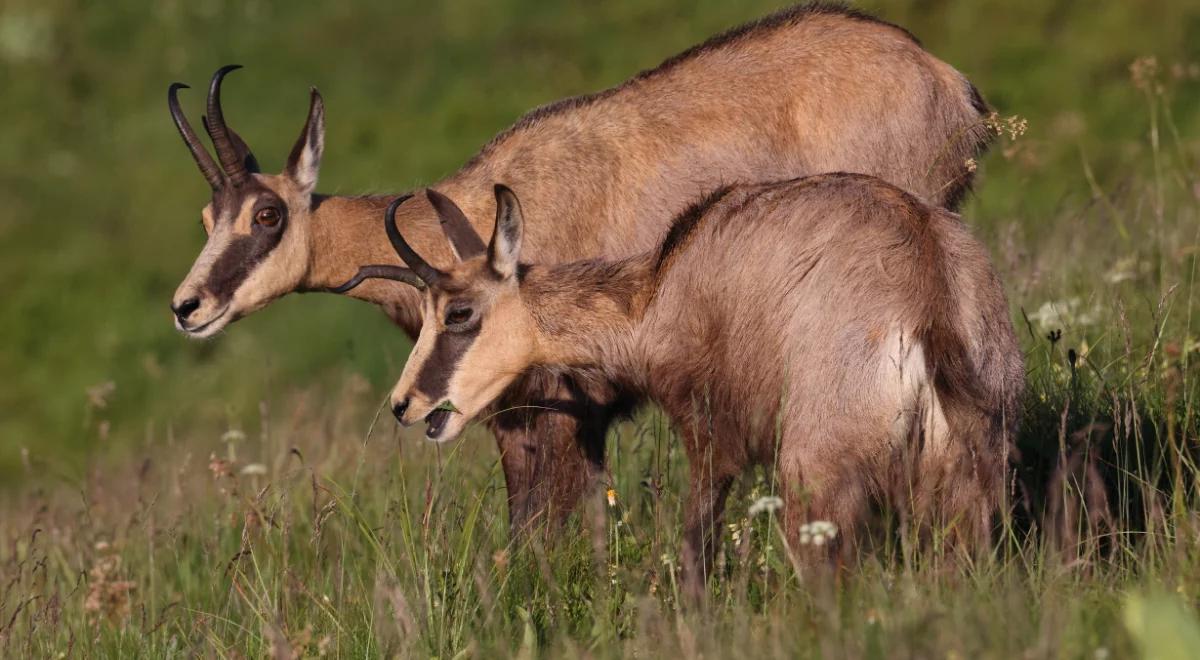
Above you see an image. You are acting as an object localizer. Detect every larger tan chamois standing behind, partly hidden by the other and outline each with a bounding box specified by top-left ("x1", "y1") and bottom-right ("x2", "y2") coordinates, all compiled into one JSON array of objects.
[{"x1": 168, "y1": 5, "x2": 986, "y2": 528}]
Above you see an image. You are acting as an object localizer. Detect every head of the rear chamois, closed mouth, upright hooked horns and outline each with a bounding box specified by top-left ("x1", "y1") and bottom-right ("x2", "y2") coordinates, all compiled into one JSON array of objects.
[{"x1": 167, "y1": 65, "x2": 325, "y2": 337}]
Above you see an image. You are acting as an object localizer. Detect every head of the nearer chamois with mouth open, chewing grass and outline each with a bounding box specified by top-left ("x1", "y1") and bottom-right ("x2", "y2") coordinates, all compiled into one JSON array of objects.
[{"x1": 384, "y1": 185, "x2": 535, "y2": 442}]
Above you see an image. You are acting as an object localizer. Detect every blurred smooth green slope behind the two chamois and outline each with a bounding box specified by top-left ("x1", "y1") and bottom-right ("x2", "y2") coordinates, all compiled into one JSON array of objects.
[{"x1": 0, "y1": 0, "x2": 1200, "y2": 482}]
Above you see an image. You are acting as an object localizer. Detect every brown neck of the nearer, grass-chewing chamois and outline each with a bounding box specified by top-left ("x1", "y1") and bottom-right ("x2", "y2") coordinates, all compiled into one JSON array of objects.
[{"x1": 521, "y1": 254, "x2": 654, "y2": 380}]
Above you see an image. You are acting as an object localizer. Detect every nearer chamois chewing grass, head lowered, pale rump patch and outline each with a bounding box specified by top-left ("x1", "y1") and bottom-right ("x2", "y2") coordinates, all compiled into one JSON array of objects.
[{"x1": 385, "y1": 180, "x2": 1024, "y2": 600}]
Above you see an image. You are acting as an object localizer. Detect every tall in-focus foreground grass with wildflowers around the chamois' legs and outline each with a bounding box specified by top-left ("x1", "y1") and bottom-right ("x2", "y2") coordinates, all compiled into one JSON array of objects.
[{"x1": 0, "y1": 326, "x2": 1200, "y2": 658}]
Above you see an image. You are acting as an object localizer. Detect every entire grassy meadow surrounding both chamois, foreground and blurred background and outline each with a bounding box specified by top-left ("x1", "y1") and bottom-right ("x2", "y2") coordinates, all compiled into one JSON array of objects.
[{"x1": 0, "y1": 0, "x2": 1200, "y2": 660}]
